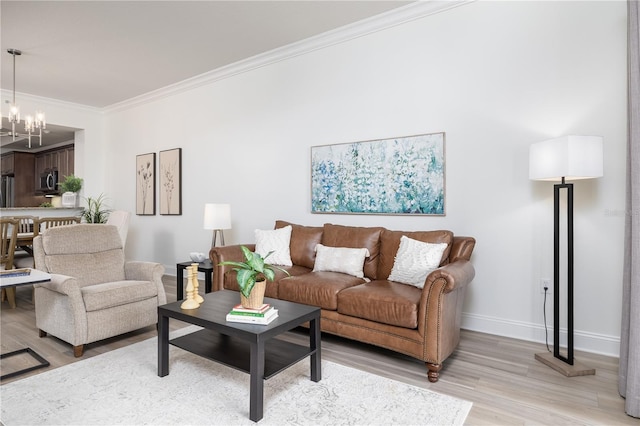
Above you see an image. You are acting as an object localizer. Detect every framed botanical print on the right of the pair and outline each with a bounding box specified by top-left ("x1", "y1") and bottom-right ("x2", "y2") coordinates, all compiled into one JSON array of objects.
[{"x1": 159, "y1": 148, "x2": 182, "y2": 215}]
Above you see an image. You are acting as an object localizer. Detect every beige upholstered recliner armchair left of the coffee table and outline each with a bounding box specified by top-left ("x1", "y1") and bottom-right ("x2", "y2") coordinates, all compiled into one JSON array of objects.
[{"x1": 33, "y1": 224, "x2": 167, "y2": 357}]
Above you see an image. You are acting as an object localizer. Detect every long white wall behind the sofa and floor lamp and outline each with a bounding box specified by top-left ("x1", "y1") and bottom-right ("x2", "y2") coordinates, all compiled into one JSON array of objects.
[{"x1": 55, "y1": 1, "x2": 626, "y2": 355}]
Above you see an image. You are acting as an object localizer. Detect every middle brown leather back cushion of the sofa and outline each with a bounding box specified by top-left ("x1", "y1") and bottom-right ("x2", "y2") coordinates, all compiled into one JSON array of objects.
[{"x1": 322, "y1": 223, "x2": 382, "y2": 280}]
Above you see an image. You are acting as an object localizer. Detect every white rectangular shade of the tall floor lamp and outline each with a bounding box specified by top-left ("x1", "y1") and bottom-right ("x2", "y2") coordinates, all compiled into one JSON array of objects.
[{"x1": 529, "y1": 135, "x2": 603, "y2": 181}]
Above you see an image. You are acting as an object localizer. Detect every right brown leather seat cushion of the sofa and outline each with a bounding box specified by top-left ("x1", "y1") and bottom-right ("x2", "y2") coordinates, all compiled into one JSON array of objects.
[{"x1": 338, "y1": 280, "x2": 422, "y2": 328}]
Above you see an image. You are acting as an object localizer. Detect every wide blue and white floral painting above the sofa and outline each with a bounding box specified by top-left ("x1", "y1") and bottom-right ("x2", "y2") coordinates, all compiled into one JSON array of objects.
[{"x1": 311, "y1": 133, "x2": 445, "y2": 215}]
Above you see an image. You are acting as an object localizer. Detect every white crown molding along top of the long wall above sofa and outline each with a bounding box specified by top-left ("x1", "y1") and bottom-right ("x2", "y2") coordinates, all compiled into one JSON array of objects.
[{"x1": 102, "y1": 0, "x2": 476, "y2": 113}]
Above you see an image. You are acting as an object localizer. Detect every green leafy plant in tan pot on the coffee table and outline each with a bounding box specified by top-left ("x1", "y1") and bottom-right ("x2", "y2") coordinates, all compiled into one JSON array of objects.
[{"x1": 220, "y1": 246, "x2": 289, "y2": 309}]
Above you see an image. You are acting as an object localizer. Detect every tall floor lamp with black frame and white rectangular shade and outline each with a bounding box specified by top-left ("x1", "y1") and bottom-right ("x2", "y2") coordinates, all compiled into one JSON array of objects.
[{"x1": 529, "y1": 135, "x2": 603, "y2": 377}]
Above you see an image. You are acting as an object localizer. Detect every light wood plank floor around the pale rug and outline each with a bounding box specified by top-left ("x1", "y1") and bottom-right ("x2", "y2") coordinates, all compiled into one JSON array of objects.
[{"x1": 0, "y1": 276, "x2": 640, "y2": 426}]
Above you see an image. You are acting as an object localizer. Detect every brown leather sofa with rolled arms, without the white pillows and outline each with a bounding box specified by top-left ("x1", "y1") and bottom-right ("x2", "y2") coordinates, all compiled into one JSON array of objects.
[{"x1": 209, "y1": 220, "x2": 475, "y2": 382}]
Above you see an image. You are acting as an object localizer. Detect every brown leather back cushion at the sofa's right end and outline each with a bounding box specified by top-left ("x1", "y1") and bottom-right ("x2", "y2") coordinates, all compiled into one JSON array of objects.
[{"x1": 377, "y1": 229, "x2": 453, "y2": 280}]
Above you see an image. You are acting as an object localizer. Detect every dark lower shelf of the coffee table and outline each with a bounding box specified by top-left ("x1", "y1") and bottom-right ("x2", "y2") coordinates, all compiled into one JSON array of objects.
[{"x1": 169, "y1": 329, "x2": 315, "y2": 380}]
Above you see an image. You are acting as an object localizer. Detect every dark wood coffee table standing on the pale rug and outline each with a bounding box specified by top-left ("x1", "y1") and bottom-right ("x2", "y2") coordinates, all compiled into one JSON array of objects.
[{"x1": 158, "y1": 290, "x2": 322, "y2": 422}]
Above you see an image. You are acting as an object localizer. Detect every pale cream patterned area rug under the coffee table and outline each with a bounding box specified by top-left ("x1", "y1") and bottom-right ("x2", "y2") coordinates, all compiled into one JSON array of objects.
[{"x1": 0, "y1": 326, "x2": 471, "y2": 426}]
